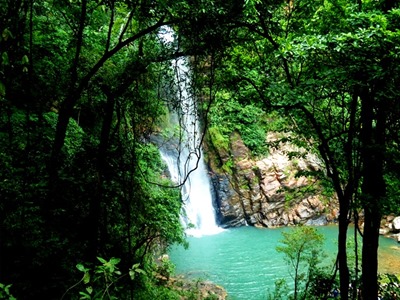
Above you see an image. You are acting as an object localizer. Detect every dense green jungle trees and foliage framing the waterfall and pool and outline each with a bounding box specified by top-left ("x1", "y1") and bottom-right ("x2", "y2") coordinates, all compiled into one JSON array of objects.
[{"x1": 0, "y1": 0, "x2": 400, "y2": 300}]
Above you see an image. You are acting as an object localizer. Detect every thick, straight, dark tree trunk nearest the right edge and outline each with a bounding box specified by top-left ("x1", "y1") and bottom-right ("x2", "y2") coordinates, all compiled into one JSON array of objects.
[{"x1": 361, "y1": 92, "x2": 386, "y2": 300}]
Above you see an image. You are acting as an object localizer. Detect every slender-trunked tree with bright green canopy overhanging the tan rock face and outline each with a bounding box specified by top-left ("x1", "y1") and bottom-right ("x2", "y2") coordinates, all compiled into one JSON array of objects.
[{"x1": 214, "y1": 1, "x2": 360, "y2": 297}]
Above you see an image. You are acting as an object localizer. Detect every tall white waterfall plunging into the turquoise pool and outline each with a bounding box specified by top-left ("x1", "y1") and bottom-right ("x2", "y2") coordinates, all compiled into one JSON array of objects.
[{"x1": 160, "y1": 27, "x2": 223, "y2": 236}]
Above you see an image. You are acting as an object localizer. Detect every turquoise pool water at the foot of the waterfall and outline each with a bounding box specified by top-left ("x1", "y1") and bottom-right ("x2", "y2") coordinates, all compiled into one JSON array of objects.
[{"x1": 169, "y1": 226, "x2": 400, "y2": 300}]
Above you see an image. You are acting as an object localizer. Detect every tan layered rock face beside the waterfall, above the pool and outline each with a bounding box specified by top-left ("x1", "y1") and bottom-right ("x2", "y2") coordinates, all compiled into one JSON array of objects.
[{"x1": 210, "y1": 133, "x2": 338, "y2": 227}]
